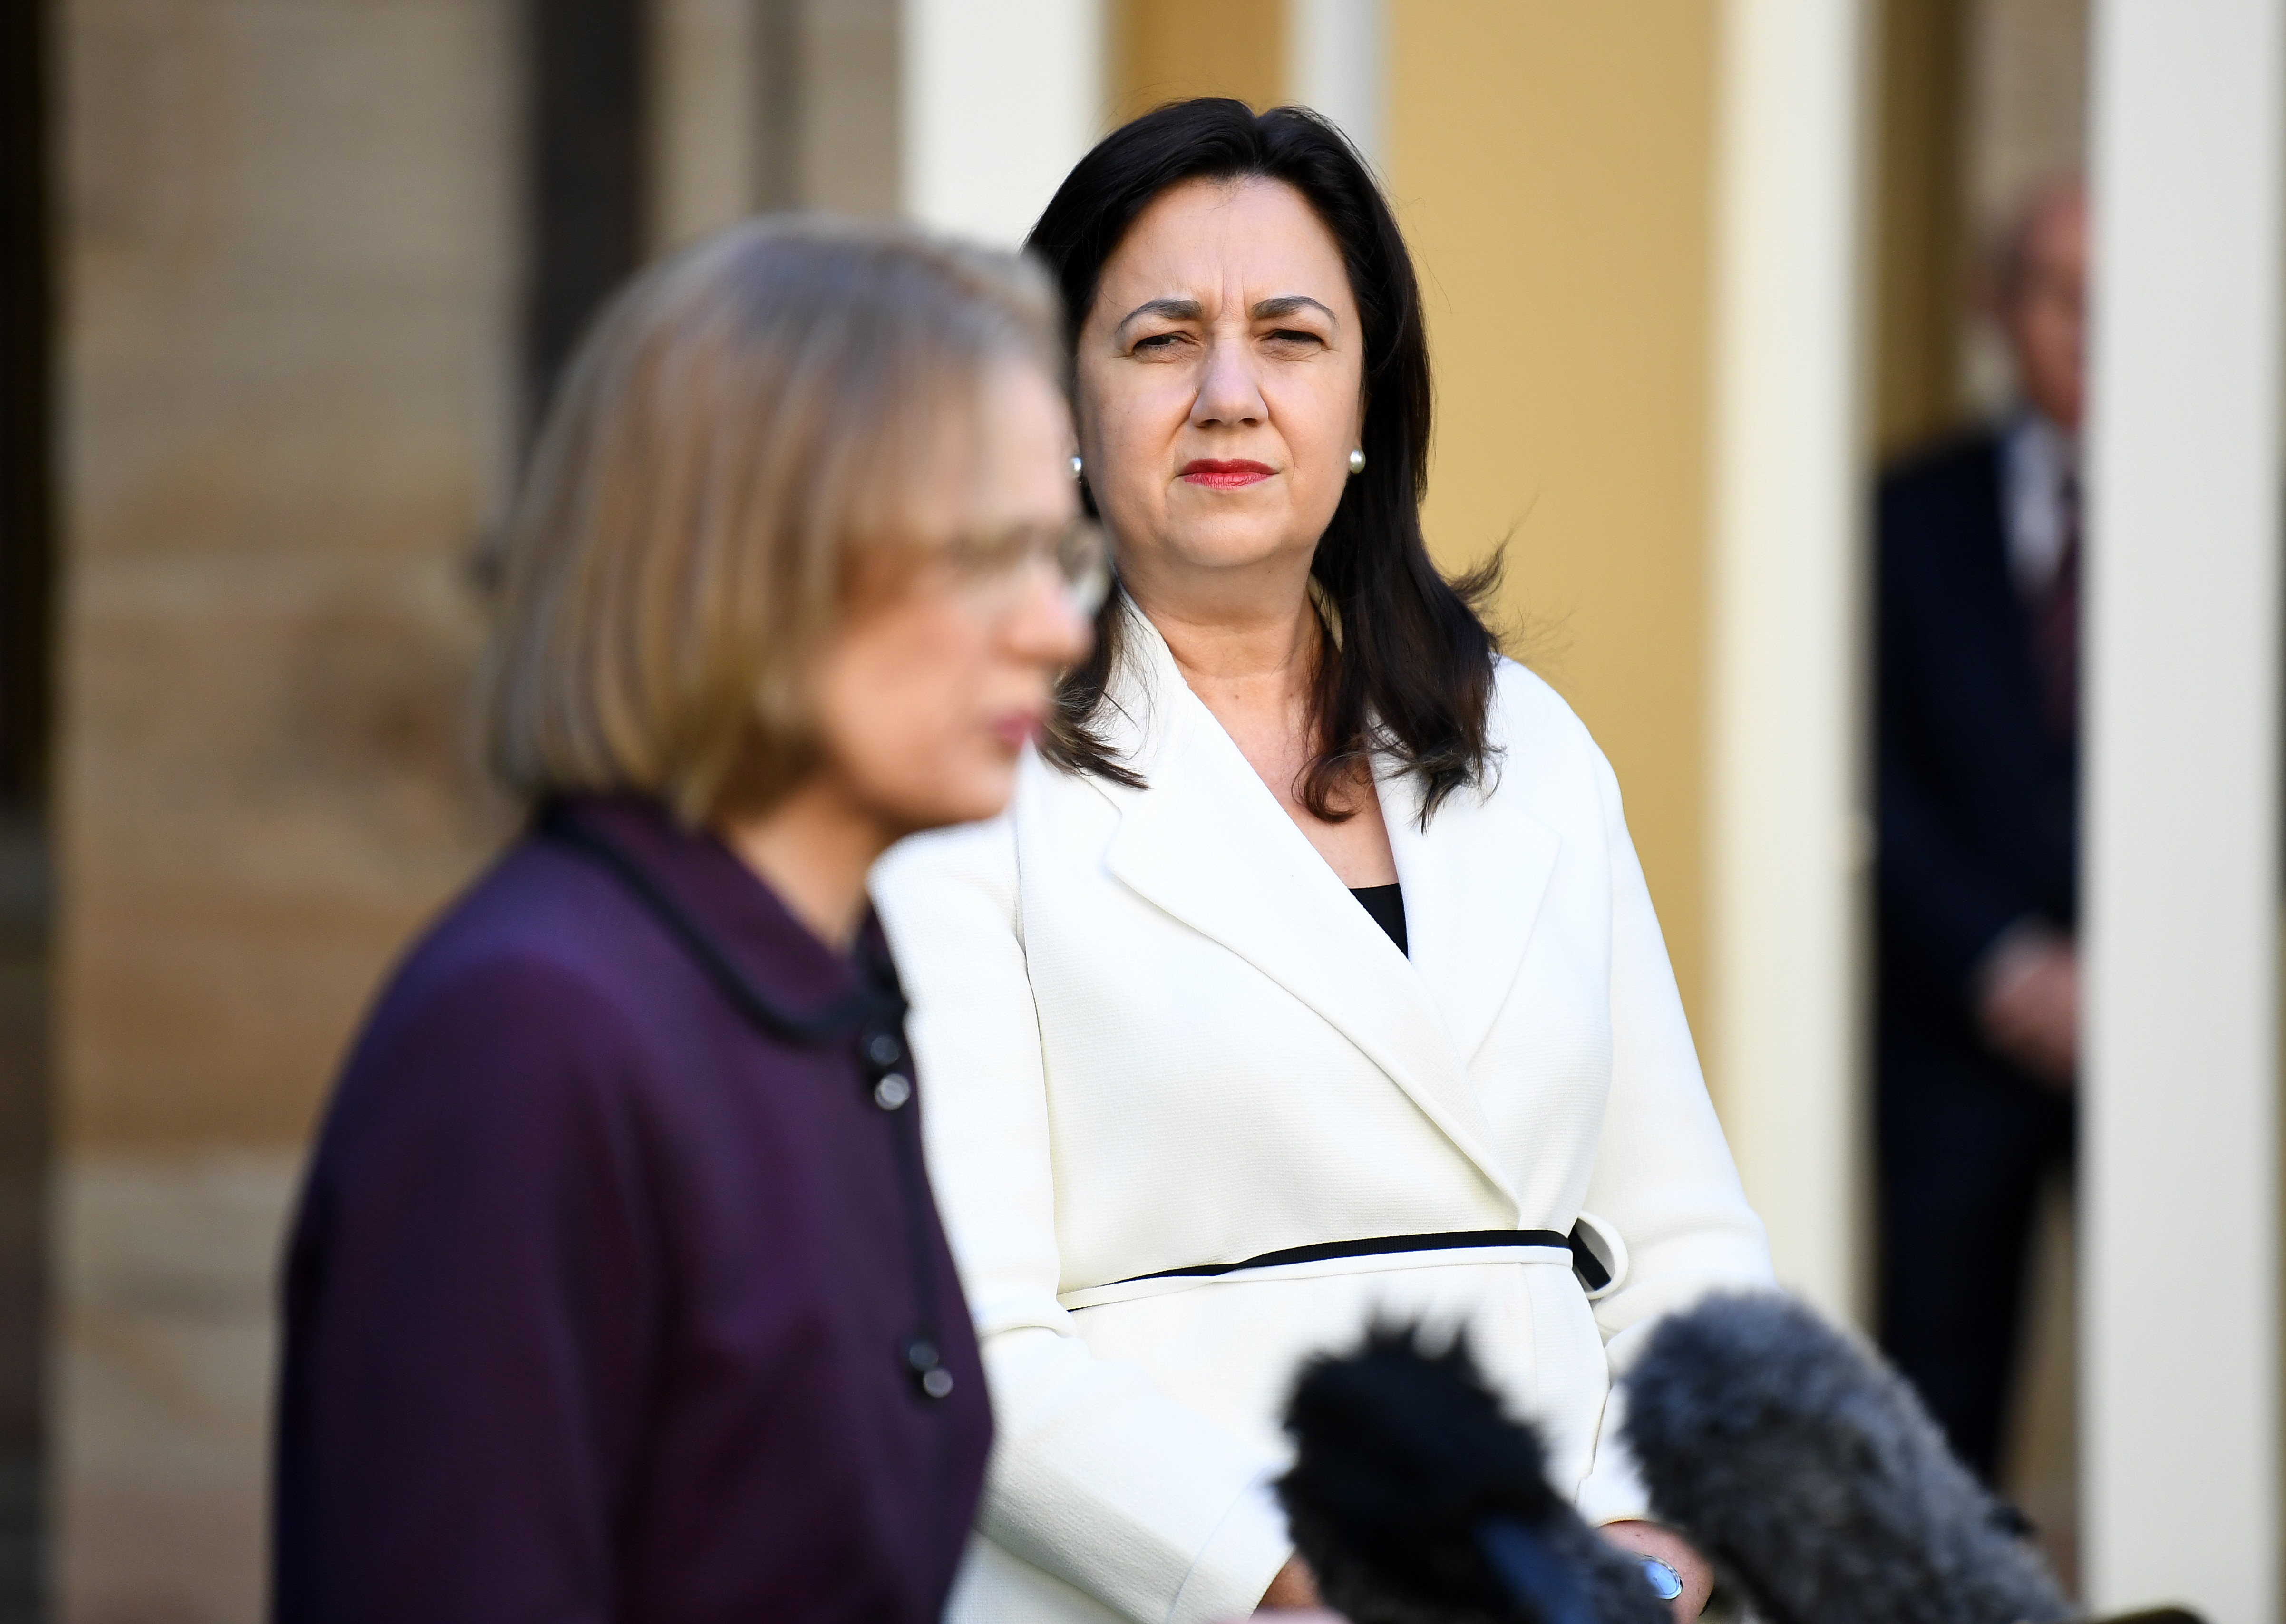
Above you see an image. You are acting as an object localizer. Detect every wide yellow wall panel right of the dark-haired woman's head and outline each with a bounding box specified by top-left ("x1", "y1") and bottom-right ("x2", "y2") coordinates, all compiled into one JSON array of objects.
[{"x1": 1390, "y1": 0, "x2": 1717, "y2": 1020}]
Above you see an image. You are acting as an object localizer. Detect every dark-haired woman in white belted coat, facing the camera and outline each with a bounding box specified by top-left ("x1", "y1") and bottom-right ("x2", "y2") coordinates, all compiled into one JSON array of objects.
[{"x1": 875, "y1": 101, "x2": 1770, "y2": 1624}]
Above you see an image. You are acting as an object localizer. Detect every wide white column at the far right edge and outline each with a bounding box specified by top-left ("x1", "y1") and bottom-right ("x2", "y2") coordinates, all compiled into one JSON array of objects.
[{"x1": 2080, "y1": 0, "x2": 2286, "y2": 1624}]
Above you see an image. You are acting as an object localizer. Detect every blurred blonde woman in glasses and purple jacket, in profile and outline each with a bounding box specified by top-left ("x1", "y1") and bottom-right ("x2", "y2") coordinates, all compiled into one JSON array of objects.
[{"x1": 274, "y1": 224, "x2": 1099, "y2": 1624}]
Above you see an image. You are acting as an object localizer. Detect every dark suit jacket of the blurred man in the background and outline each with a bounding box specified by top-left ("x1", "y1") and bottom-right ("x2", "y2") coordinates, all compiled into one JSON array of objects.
[{"x1": 1877, "y1": 432, "x2": 2078, "y2": 1079}]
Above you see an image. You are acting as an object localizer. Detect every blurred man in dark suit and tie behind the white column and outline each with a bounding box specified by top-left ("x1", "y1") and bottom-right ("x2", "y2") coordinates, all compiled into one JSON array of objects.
[{"x1": 1877, "y1": 181, "x2": 2087, "y2": 1480}]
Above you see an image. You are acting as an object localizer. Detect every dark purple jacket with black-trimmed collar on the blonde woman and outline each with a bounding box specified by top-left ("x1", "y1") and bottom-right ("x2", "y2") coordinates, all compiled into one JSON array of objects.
[{"x1": 272, "y1": 800, "x2": 992, "y2": 1624}]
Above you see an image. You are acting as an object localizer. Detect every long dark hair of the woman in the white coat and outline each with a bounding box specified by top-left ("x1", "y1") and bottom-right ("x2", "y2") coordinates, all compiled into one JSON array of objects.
[{"x1": 1026, "y1": 98, "x2": 1499, "y2": 824}]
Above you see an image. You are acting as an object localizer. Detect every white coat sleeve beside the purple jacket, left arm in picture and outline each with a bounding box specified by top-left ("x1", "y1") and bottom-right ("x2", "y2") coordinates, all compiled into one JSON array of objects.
[{"x1": 873, "y1": 819, "x2": 1292, "y2": 1624}]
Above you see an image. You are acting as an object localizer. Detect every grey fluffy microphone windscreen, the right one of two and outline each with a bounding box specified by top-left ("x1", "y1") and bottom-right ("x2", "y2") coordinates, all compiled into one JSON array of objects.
[{"x1": 1623, "y1": 1293, "x2": 2073, "y2": 1624}]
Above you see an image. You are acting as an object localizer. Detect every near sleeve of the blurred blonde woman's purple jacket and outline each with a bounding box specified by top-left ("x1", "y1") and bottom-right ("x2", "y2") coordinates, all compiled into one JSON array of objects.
[{"x1": 274, "y1": 965, "x2": 656, "y2": 1624}]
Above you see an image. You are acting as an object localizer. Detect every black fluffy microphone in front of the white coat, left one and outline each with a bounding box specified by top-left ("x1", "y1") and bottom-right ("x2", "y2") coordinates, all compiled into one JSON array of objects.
[{"x1": 1278, "y1": 1324, "x2": 1671, "y2": 1624}]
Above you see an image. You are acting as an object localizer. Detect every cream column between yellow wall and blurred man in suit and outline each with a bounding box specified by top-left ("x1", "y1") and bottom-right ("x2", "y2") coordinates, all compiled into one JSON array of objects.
[{"x1": 1708, "y1": 0, "x2": 1872, "y2": 1315}]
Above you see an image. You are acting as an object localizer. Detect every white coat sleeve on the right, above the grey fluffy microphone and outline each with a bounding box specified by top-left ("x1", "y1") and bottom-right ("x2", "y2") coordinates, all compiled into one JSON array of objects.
[{"x1": 1577, "y1": 746, "x2": 1774, "y2": 1523}]
